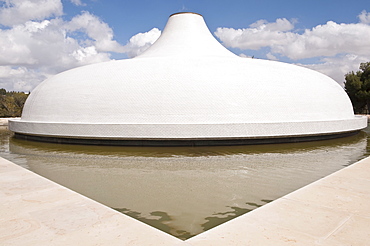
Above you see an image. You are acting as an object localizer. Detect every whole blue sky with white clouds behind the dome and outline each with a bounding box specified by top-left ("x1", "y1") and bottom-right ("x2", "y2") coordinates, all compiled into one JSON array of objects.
[{"x1": 0, "y1": 0, "x2": 370, "y2": 91}]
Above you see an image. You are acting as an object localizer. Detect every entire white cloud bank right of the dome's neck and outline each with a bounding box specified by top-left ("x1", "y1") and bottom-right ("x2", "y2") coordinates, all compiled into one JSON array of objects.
[{"x1": 215, "y1": 14, "x2": 370, "y2": 84}]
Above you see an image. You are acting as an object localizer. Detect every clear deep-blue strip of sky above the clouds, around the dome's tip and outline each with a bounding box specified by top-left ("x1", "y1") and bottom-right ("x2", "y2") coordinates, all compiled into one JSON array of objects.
[{"x1": 62, "y1": 0, "x2": 370, "y2": 49}]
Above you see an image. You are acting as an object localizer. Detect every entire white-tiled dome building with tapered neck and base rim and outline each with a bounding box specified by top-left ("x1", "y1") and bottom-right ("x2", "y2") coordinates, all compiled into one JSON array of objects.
[{"x1": 9, "y1": 13, "x2": 367, "y2": 145}]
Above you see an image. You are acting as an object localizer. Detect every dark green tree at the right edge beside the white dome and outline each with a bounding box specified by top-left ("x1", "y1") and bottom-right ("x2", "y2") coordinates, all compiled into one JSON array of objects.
[{"x1": 344, "y1": 62, "x2": 370, "y2": 114}]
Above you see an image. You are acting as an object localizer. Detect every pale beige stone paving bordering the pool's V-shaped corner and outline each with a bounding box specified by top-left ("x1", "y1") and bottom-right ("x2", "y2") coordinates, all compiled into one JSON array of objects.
[{"x1": 0, "y1": 157, "x2": 370, "y2": 246}]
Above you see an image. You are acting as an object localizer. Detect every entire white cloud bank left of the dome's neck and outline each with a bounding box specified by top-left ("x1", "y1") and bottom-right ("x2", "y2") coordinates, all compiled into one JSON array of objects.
[{"x1": 0, "y1": 3, "x2": 161, "y2": 91}]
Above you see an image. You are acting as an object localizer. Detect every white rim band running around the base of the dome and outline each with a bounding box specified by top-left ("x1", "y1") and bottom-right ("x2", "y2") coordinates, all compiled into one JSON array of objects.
[{"x1": 11, "y1": 116, "x2": 367, "y2": 140}]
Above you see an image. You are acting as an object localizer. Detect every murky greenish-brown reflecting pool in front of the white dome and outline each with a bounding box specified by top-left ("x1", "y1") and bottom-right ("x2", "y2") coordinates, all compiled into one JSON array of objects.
[{"x1": 0, "y1": 128, "x2": 369, "y2": 239}]
